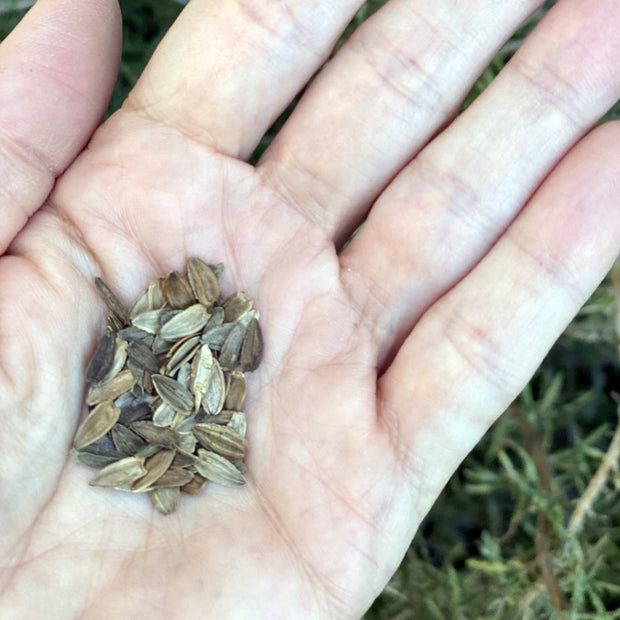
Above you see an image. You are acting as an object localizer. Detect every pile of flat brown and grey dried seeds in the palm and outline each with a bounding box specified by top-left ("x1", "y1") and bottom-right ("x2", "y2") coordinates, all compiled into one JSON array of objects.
[{"x1": 73, "y1": 258, "x2": 263, "y2": 514}]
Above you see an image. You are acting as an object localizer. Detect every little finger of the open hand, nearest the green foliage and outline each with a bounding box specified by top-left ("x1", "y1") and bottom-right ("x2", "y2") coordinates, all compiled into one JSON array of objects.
[{"x1": 380, "y1": 123, "x2": 620, "y2": 514}]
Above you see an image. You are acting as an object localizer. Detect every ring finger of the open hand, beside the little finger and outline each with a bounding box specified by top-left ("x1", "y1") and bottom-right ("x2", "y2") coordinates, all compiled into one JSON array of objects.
[{"x1": 342, "y1": 0, "x2": 620, "y2": 355}]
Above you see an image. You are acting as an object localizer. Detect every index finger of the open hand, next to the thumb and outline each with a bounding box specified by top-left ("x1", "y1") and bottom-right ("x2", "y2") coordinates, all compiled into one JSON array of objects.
[{"x1": 125, "y1": 0, "x2": 362, "y2": 158}]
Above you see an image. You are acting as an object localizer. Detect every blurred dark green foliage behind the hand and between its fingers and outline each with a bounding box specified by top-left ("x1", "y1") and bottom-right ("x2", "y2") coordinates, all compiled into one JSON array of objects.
[{"x1": 0, "y1": 0, "x2": 620, "y2": 620}]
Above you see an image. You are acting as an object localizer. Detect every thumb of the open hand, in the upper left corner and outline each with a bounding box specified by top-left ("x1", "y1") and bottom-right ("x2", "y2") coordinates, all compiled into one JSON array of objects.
[{"x1": 0, "y1": 0, "x2": 121, "y2": 253}]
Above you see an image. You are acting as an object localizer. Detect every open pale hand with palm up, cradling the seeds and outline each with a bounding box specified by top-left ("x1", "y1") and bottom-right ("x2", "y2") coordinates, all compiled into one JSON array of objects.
[{"x1": 0, "y1": 0, "x2": 620, "y2": 619}]
